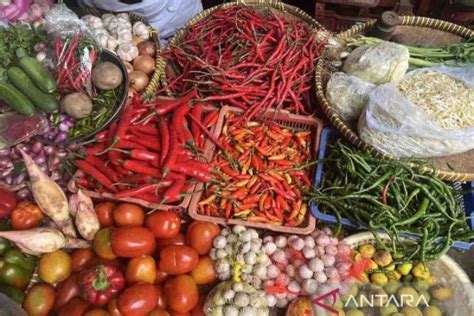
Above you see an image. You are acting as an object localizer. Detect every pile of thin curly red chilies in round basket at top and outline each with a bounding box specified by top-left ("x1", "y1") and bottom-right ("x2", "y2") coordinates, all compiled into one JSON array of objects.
[{"x1": 163, "y1": 6, "x2": 327, "y2": 120}]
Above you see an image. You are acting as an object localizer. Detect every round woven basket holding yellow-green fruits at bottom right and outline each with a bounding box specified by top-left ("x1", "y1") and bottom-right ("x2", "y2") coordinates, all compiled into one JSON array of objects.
[{"x1": 344, "y1": 232, "x2": 474, "y2": 315}]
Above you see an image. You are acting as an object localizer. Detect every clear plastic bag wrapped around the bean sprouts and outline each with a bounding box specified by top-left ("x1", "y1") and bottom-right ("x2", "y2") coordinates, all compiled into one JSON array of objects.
[{"x1": 359, "y1": 66, "x2": 474, "y2": 157}]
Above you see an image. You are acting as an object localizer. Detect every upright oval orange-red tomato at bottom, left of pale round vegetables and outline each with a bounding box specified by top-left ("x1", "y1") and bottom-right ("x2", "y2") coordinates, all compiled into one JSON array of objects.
[{"x1": 163, "y1": 274, "x2": 199, "y2": 313}]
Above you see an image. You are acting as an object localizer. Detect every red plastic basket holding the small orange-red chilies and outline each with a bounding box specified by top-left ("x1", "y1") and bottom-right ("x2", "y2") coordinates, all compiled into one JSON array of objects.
[{"x1": 188, "y1": 106, "x2": 323, "y2": 234}]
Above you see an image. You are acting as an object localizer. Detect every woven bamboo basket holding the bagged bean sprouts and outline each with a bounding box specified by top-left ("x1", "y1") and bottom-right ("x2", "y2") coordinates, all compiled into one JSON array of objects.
[{"x1": 315, "y1": 16, "x2": 474, "y2": 181}]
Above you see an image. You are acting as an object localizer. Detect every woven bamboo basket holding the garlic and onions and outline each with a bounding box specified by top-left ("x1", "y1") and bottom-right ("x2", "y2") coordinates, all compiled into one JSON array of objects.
[{"x1": 83, "y1": 7, "x2": 166, "y2": 97}]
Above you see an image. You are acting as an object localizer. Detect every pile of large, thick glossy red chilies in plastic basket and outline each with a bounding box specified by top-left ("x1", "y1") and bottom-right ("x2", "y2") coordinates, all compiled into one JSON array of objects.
[{"x1": 76, "y1": 91, "x2": 218, "y2": 204}]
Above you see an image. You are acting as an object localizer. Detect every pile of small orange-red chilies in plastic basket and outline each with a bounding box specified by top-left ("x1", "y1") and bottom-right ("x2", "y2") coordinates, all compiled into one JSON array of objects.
[{"x1": 198, "y1": 112, "x2": 312, "y2": 226}]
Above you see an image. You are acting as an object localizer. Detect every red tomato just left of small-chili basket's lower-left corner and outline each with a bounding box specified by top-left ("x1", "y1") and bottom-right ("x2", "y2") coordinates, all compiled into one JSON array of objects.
[{"x1": 145, "y1": 211, "x2": 181, "y2": 239}]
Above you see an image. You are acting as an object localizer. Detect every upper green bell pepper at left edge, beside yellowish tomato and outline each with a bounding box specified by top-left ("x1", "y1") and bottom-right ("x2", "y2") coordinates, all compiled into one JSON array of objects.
[{"x1": 0, "y1": 249, "x2": 36, "y2": 289}]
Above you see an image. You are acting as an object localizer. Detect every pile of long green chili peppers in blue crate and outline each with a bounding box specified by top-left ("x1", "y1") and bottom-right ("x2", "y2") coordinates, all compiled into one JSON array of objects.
[{"x1": 308, "y1": 140, "x2": 474, "y2": 262}]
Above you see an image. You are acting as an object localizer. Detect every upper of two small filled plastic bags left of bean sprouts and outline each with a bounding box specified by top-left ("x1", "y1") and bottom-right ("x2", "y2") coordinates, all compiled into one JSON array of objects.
[{"x1": 343, "y1": 42, "x2": 410, "y2": 84}]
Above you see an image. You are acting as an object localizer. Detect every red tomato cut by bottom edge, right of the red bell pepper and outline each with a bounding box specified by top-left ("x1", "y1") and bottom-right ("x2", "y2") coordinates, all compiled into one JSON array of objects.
[{"x1": 118, "y1": 283, "x2": 160, "y2": 316}]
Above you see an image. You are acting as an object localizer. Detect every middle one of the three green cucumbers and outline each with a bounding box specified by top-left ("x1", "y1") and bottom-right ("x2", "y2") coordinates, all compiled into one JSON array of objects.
[{"x1": 7, "y1": 66, "x2": 59, "y2": 114}]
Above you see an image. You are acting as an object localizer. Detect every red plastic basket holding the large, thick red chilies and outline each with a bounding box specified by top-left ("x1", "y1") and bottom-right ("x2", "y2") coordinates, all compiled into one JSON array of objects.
[{"x1": 68, "y1": 106, "x2": 219, "y2": 211}]
